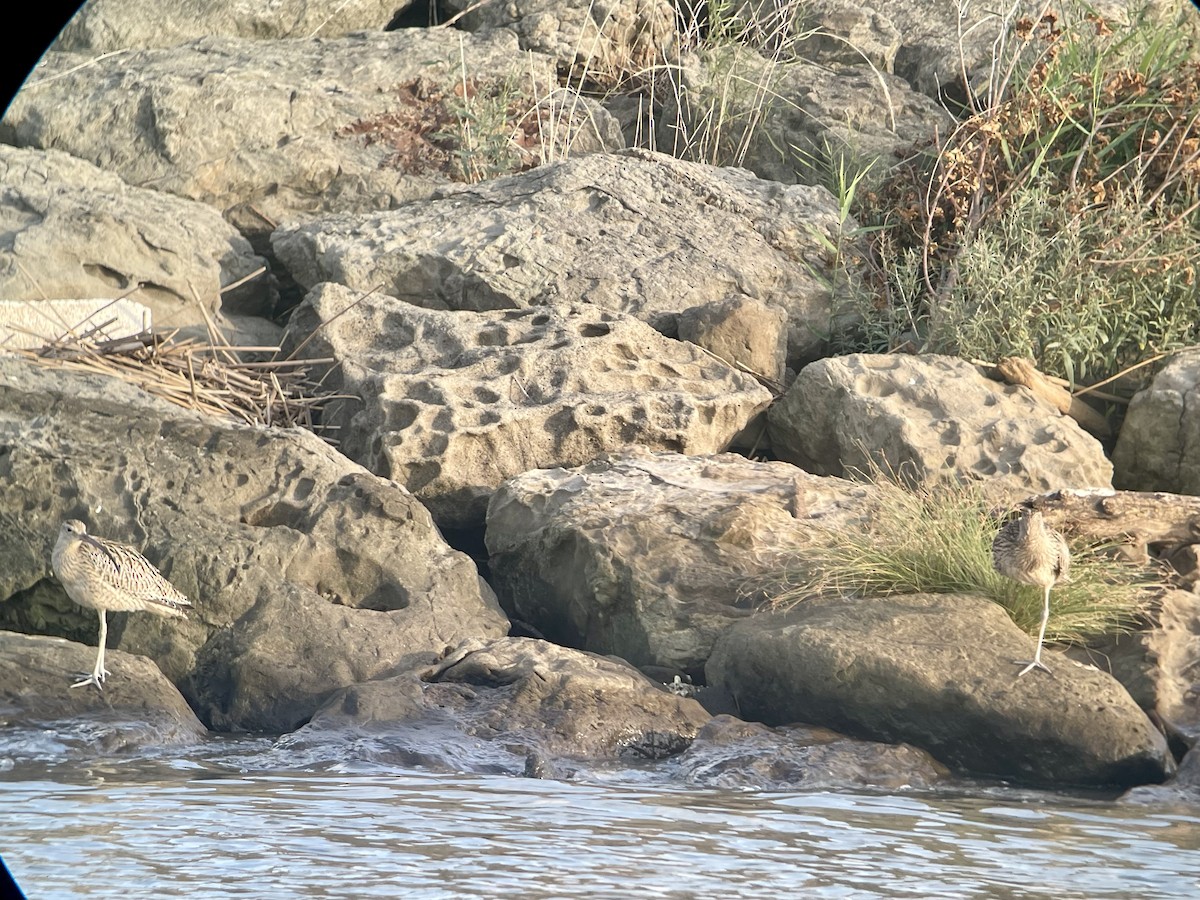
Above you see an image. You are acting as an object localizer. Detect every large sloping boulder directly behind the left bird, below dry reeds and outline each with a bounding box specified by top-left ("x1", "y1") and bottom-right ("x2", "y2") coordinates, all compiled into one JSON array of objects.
[{"x1": 0, "y1": 359, "x2": 508, "y2": 732}]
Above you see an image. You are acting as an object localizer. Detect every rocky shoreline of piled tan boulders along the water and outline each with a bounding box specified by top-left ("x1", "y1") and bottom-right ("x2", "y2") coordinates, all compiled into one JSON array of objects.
[{"x1": 0, "y1": 0, "x2": 1200, "y2": 798}]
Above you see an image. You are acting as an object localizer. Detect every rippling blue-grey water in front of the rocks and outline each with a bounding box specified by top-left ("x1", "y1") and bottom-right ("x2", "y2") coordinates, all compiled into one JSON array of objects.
[{"x1": 0, "y1": 740, "x2": 1200, "y2": 900}]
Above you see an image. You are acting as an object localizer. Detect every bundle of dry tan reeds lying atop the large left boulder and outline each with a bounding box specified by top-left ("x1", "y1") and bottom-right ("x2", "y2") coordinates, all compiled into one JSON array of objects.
[{"x1": 17, "y1": 323, "x2": 338, "y2": 443}]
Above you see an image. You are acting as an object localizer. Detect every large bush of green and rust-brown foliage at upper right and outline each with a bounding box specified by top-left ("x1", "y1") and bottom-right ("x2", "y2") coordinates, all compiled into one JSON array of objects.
[{"x1": 835, "y1": 5, "x2": 1200, "y2": 394}]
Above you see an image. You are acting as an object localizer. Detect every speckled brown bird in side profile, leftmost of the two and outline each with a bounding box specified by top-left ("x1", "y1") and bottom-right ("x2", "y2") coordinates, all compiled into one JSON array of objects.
[{"x1": 50, "y1": 518, "x2": 192, "y2": 691}]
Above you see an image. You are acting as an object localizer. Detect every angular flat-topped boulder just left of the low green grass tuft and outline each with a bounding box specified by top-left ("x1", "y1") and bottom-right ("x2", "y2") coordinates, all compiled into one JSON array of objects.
[{"x1": 486, "y1": 450, "x2": 871, "y2": 676}]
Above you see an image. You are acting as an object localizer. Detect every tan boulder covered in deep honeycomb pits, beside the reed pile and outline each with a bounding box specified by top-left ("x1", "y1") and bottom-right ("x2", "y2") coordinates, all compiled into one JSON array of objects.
[{"x1": 288, "y1": 284, "x2": 770, "y2": 528}]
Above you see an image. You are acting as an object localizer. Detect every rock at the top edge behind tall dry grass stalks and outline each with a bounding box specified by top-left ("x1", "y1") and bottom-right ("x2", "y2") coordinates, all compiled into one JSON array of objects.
[{"x1": 446, "y1": 0, "x2": 678, "y2": 83}]
